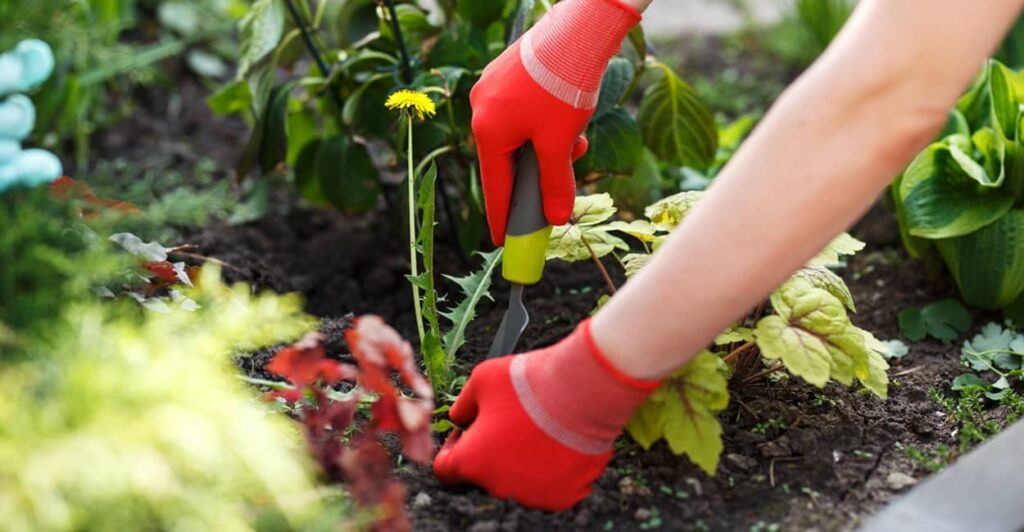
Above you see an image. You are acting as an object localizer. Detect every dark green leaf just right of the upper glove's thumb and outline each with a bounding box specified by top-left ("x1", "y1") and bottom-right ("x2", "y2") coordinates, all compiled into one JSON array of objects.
[{"x1": 573, "y1": 107, "x2": 644, "y2": 177}]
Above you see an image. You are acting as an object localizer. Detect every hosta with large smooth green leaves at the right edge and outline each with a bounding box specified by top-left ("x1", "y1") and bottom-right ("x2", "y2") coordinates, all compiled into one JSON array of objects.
[{"x1": 892, "y1": 60, "x2": 1024, "y2": 318}]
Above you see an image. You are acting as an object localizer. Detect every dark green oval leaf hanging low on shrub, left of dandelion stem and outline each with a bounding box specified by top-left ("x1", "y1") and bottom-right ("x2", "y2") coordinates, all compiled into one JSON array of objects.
[{"x1": 317, "y1": 135, "x2": 380, "y2": 213}]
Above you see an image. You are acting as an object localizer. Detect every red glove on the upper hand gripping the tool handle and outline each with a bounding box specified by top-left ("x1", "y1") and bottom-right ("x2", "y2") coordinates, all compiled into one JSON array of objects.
[{"x1": 469, "y1": 0, "x2": 640, "y2": 246}]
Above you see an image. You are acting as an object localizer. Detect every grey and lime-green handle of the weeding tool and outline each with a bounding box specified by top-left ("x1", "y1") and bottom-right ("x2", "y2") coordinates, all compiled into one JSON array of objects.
[{"x1": 502, "y1": 142, "x2": 551, "y2": 284}]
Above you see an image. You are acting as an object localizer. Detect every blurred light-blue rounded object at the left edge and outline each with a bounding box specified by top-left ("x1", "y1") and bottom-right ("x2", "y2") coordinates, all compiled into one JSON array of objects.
[{"x1": 0, "y1": 39, "x2": 63, "y2": 192}]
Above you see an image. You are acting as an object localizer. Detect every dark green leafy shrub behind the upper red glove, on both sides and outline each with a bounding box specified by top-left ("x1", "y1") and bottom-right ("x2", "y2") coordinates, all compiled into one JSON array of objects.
[{"x1": 210, "y1": 0, "x2": 718, "y2": 252}]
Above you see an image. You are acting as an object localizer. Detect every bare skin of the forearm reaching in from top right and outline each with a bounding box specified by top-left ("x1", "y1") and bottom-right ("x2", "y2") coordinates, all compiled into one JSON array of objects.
[{"x1": 593, "y1": 0, "x2": 1020, "y2": 378}]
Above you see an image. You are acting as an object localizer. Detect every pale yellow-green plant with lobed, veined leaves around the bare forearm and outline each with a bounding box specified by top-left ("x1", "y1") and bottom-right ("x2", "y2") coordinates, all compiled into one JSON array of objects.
[{"x1": 548, "y1": 191, "x2": 889, "y2": 474}]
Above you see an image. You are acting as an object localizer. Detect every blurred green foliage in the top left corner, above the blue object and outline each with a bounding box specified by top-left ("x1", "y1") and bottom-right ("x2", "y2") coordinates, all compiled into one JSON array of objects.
[{"x1": 0, "y1": 0, "x2": 242, "y2": 166}]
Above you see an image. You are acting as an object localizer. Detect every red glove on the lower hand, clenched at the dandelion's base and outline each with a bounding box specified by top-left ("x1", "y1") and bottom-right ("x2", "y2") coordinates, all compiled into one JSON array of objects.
[{"x1": 434, "y1": 320, "x2": 660, "y2": 511}]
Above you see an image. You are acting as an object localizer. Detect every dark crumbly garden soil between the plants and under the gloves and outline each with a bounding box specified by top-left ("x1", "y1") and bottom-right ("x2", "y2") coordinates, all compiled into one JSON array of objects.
[{"x1": 88, "y1": 48, "x2": 983, "y2": 531}]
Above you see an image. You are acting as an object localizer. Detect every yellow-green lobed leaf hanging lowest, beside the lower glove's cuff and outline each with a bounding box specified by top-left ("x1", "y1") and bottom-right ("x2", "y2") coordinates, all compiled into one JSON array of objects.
[{"x1": 626, "y1": 351, "x2": 729, "y2": 475}]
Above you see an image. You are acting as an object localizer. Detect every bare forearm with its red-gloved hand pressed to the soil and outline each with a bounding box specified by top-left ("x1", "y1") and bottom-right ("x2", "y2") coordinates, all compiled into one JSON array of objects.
[{"x1": 434, "y1": 0, "x2": 1022, "y2": 509}]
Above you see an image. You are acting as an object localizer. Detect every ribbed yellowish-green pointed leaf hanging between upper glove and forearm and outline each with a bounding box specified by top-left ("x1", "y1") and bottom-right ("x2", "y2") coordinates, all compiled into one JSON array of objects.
[{"x1": 637, "y1": 65, "x2": 718, "y2": 168}]
